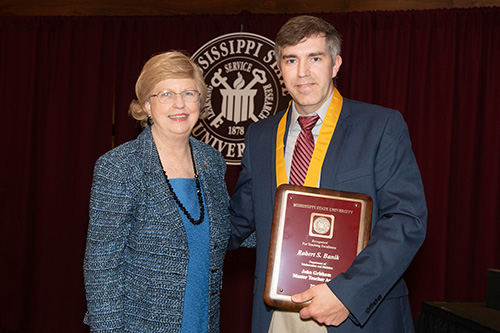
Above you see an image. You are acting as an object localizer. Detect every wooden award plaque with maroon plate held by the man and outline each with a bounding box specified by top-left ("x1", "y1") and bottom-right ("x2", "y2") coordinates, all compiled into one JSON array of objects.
[{"x1": 264, "y1": 184, "x2": 373, "y2": 310}]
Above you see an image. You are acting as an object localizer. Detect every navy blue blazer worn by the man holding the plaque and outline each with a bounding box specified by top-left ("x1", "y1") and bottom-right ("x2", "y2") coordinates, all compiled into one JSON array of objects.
[{"x1": 230, "y1": 98, "x2": 427, "y2": 333}]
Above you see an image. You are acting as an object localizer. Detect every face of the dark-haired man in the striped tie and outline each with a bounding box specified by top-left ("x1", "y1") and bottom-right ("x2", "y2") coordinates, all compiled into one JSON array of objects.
[{"x1": 281, "y1": 36, "x2": 342, "y2": 115}]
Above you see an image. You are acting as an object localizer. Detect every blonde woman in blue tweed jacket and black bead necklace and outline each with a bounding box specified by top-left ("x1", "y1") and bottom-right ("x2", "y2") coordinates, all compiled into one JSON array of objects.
[{"x1": 84, "y1": 51, "x2": 230, "y2": 333}]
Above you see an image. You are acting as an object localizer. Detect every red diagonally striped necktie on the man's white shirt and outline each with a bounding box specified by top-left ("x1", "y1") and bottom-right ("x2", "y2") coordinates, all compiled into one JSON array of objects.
[{"x1": 289, "y1": 115, "x2": 319, "y2": 185}]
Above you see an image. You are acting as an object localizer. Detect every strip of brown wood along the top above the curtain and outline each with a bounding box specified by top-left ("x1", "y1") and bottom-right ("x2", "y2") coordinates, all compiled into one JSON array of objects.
[{"x1": 0, "y1": 0, "x2": 500, "y2": 16}]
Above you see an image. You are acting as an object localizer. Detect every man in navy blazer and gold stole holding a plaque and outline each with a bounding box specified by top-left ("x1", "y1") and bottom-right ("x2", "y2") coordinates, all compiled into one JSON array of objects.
[{"x1": 230, "y1": 16, "x2": 427, "y2": 333}]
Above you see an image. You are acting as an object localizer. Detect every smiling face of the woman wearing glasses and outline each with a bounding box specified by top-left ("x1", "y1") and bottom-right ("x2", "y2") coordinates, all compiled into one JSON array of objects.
[{"x1": 146, "y1": 79, "x2": 200, "y2": 137}]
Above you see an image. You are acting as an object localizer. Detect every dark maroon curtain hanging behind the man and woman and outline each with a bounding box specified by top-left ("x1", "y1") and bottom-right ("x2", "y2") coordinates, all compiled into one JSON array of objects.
[{"x1": 0, "y1": 8, "x2": 500, "y2": 332}]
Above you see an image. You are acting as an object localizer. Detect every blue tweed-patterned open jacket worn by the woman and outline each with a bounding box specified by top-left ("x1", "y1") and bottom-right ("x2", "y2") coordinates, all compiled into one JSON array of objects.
[{"x1": 83, "y1": 127, "x2": 230, "y2": 332}]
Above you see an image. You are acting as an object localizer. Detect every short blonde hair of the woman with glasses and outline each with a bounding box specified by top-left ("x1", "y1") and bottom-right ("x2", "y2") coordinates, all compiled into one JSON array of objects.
[{"x1": 128, "y1": 51, "x2": 207, "y2": 127}]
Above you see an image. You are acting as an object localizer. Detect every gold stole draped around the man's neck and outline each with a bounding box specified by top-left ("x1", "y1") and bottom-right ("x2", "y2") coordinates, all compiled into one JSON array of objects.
[{"x1": 276, "y1": 87, "x2": 343, "y2": 187}]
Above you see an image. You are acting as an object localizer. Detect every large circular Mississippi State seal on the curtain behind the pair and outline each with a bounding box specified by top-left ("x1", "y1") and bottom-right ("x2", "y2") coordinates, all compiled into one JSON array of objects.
[{"x1": 191, "y1": 32, "x2": 288, "y2": 165}]
